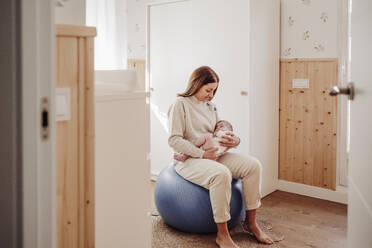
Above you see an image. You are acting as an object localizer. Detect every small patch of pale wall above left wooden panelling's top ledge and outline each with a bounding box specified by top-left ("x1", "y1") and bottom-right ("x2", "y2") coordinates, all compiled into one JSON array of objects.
[{"x1": 53, "y1": 0, "x2": 85, "y2": 25}]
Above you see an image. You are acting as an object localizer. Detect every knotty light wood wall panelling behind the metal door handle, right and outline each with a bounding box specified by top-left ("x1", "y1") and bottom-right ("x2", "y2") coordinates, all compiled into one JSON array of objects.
[{"x1": 279, "y1": 59, "x2": 338, "y2": 190}]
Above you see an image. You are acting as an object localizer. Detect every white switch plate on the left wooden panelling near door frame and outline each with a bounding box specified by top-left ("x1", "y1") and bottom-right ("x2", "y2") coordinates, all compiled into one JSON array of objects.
[{"x1": 56, "y1": 88, "x2": 71, "y2": 121}]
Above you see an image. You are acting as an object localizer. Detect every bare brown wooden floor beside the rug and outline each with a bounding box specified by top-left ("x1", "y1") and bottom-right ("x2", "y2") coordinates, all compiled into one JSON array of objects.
[{"x1": 151, "y1": 182, "x2": 347, "y2": 248}]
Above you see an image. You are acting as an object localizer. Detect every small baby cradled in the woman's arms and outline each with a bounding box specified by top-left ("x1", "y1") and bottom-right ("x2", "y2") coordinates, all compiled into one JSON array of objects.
[{"x1": 173, "y1": 120, "x2": 233, "y2": 162}]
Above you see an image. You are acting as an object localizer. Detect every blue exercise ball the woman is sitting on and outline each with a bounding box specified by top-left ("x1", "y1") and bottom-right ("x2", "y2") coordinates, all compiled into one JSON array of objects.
[{"x1": 154, "y1": 165, "x2": 245, "y2": 234}]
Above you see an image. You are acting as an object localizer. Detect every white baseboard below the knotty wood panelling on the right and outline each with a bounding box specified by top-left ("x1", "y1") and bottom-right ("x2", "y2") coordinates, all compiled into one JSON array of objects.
[{"x1": 277, "y1": 180, "x2": 347, "y2": 204}]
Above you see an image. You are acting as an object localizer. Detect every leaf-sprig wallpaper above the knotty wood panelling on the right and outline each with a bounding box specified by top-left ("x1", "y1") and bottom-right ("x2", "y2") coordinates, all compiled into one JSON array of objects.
[{"x1": 281, "y1": 0, "x2": 340, "y2": 58}]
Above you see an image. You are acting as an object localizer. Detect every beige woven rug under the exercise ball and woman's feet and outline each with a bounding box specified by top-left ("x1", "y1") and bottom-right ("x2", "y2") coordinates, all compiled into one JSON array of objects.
[{"x1": 151, "y1": 211, "x2": 284, "y2": 248}]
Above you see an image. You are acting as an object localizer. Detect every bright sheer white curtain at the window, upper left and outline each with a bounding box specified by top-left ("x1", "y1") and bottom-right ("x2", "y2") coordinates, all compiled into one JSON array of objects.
[{"x1": 86, "y1": 0, "x2": 127, "y2": 70}]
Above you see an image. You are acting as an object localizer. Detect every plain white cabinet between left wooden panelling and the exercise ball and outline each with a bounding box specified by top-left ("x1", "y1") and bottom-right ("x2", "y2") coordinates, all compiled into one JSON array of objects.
[{"x1": 95, "y1": 90, "x2": 151, "y2": 248}]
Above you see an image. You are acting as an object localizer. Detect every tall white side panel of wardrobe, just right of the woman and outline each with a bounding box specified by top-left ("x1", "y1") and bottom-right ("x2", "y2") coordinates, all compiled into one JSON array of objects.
[{"x1": 248, "y1": 0, "x2": 280, "y2": 198}]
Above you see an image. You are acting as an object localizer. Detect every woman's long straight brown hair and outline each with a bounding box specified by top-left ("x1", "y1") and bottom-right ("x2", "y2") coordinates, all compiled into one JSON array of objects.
[{"x1": 177, "y1": 66, "x2": 220, "y2": 97}]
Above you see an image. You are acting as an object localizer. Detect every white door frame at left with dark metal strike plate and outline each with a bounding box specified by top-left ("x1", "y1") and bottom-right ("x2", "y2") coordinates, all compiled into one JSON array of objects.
[{"x1": 19, "y1": 0, "x2": 57, "y2": 248}]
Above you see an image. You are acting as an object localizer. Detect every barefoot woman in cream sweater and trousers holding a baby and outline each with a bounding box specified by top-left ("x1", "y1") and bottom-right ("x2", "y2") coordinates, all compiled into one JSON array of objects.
[{"x1": 168, "y1": 66, "x2": 273, "y2": 248}]
